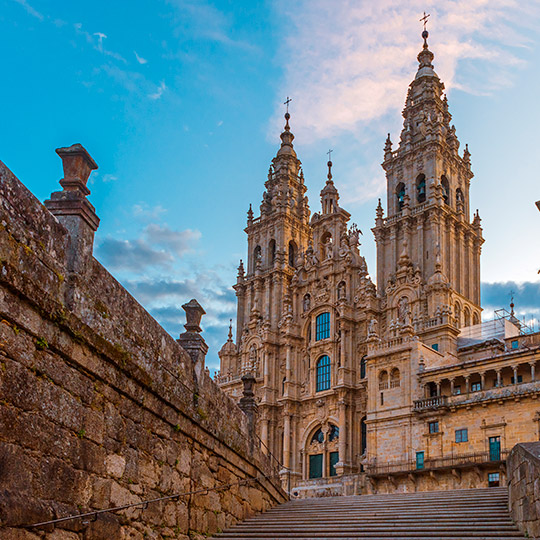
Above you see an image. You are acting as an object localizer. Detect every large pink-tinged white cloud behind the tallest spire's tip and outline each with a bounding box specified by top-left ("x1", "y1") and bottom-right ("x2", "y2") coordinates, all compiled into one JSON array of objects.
[{"x1": 272, "y1": 0, "x2": 540, "y2": 143}]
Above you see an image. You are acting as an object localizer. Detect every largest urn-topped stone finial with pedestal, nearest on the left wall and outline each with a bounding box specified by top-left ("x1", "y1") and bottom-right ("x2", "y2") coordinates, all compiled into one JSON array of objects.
[{"x1": 44, "y1": 144, "x2": 99, "y2": 274}]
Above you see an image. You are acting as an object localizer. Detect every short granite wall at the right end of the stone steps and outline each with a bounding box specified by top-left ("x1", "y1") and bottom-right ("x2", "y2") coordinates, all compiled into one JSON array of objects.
[{"x1": 507, "y1": 442, "x2": 540, "y2": 538}]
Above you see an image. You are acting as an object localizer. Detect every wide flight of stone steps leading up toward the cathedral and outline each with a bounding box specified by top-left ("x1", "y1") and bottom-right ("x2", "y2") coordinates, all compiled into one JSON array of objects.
[{"x1": 216, "y1": 488, "x2": 524, "y2": 540}]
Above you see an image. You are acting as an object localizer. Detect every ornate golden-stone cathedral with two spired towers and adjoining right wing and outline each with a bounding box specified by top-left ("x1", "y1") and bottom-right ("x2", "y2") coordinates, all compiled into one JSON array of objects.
[{"x1": 217, "y1": 30, "x2": 540, "y2": 497}]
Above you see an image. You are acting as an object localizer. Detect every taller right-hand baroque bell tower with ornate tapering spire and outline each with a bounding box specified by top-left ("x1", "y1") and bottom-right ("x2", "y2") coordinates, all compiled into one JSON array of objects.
[{"x1": 373, "y1": 30, "x2": 484, "y2": 354}]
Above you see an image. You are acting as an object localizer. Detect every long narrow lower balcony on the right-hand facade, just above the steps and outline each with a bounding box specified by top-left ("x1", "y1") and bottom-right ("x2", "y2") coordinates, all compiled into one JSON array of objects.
[{"x1": 366, "y1": 450, "x2": 509, "y2": 477}]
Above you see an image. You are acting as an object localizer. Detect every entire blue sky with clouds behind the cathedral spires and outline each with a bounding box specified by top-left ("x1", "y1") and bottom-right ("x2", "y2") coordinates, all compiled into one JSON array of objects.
[{"x1": 0, "y1": 0, "x2": 540, "y2": 367}]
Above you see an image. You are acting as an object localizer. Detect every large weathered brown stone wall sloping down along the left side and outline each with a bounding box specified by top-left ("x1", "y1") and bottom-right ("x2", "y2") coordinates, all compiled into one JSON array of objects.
[{"x1": 0, "y1": 155, "x2": 285, "y2": 540}]
